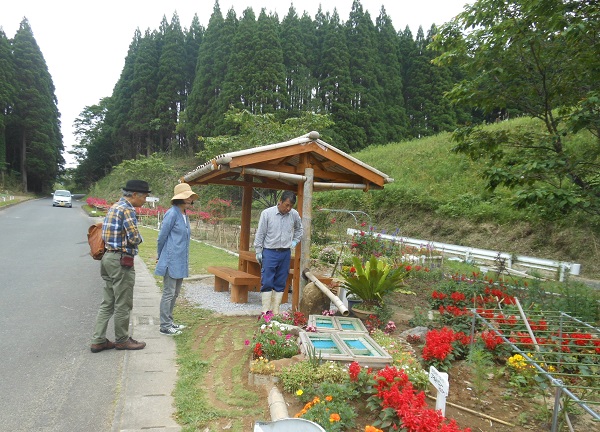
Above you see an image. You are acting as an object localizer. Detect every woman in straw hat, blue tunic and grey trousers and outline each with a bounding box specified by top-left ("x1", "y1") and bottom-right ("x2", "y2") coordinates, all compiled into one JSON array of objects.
[{"x1": 154, "y1": 183, "x2": 198, "y2": 336}]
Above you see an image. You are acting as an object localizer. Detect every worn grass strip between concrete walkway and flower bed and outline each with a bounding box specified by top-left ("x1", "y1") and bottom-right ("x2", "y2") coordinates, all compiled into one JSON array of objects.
[{"x1": 173, "y1": 305, "x2": 265, "y2": 432}]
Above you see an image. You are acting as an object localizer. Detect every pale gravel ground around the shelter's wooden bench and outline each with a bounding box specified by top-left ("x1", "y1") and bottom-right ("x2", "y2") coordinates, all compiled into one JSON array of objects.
[{"x1": 183, "y1": 276, "x2": 292, "y2": 315}]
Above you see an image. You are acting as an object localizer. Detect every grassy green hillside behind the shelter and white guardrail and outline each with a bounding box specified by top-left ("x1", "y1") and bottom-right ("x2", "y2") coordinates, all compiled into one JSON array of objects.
[{"x1": 90, "y1": 119, "x2": 600, "y2": 278}]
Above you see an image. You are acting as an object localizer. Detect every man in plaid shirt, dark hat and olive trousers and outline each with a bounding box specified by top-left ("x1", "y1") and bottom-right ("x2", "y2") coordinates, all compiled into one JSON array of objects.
[{"x1": 90, "y1": 180, "x2": 151, "y2": 353}]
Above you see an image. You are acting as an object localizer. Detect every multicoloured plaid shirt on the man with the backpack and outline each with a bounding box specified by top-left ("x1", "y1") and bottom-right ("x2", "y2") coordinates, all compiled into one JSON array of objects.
[{"x1": 102, "y1": 198, "x2": 144, "y2": 255}]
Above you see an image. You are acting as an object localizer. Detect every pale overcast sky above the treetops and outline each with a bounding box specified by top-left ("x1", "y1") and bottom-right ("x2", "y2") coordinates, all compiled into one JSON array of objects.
[{"x1": 0, "y1": 0, "x2": 472, "y2": 167}]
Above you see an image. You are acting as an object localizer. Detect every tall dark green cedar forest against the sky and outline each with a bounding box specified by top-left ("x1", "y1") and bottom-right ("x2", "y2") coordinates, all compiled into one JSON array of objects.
[{"x1": 0, "y1": 1, "x2": 490, "y2": 191}]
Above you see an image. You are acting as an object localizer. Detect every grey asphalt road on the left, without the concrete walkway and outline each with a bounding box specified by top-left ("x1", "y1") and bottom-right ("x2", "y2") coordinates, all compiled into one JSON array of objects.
[{"x1": 0, "y1": 197, "x2": 125, "y2": 431}]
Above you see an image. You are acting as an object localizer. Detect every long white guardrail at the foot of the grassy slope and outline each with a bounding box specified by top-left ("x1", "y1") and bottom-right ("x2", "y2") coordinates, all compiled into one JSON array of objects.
[{"x1": 346, "y1": 228, "x2": 581, "y2": 282}]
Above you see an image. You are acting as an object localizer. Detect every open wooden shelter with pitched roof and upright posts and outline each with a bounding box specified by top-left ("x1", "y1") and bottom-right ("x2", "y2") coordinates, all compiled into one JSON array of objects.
[{"x1": 181, "y1": 131, "x2": 393, "y2": 311}]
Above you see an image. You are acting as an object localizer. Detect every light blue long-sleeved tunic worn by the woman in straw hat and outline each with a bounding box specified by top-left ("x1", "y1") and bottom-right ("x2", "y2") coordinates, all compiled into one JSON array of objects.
[{"x1": 154, "y1": 206, "x2": 191, "y2": 279}]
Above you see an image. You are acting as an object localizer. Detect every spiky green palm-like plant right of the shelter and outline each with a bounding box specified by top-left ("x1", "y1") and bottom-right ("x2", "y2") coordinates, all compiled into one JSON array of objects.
[{"x1": 343, "y1": 256, "x2": 404, "y2": 308}]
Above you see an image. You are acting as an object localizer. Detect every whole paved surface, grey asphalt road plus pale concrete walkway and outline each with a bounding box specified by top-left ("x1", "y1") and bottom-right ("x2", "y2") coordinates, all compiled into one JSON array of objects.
[{"x1": 0, "y1": 198, "x2": 180, "y2": 432}]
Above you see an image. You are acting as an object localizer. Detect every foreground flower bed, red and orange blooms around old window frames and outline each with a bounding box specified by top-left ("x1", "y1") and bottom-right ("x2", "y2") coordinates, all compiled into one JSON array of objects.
[{"x1": 245, "y1": 311, "x2": 469, "y2": 432}]
